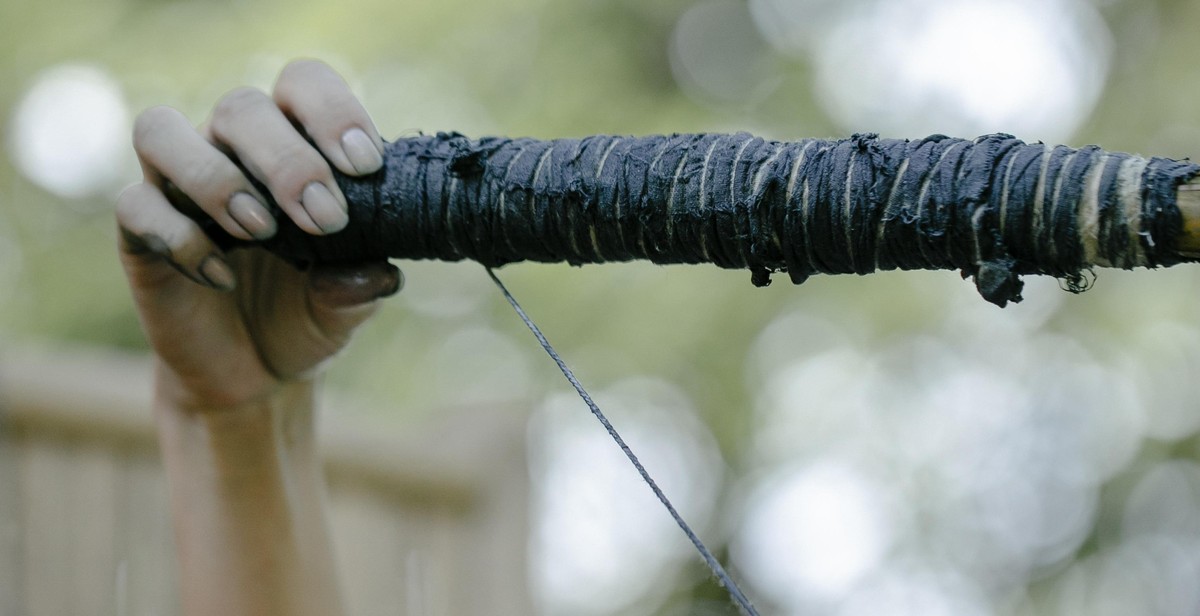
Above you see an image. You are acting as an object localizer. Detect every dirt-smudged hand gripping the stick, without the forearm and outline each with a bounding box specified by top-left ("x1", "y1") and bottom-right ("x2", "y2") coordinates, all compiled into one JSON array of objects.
[{"x1": 116, "y1": 60, "x2": 403, "y2": 409}]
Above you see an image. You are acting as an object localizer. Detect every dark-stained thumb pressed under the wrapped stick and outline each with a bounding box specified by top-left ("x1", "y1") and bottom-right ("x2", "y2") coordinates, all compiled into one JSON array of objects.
[{"x1": 308, "y1": 261, "x2": 404, "y2": 343}]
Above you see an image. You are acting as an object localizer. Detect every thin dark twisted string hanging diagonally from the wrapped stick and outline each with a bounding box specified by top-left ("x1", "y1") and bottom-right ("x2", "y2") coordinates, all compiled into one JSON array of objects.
[{"x1": 486, "y1": 268, "x2": 758, "y2": 616}]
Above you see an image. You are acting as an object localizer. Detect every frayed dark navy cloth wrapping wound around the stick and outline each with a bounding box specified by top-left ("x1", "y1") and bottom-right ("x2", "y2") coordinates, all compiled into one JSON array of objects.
[{"x1": 201, "y1": 133, "x2": 1200, "y2": 306}]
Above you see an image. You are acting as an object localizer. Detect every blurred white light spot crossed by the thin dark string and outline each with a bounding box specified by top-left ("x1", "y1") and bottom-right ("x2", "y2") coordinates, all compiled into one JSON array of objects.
[{"x1": 530, "y1": 378, "x2": 722, "y2": 616}]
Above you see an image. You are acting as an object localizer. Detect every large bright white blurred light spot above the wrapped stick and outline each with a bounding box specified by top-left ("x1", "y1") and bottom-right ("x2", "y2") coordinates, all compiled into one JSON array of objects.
[{"x1": 815, "y1": 0, "x2": 1110, "y2": 142}]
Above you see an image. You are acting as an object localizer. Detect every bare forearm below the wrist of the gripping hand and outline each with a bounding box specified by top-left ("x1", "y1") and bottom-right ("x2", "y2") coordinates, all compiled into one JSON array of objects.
[{"x1": 155, "y1": 370, "x2": 342, "y2": 616}]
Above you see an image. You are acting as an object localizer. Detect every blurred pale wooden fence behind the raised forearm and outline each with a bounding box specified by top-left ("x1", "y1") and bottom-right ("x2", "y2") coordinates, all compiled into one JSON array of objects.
[{"x1": 0, "y1": 349, "x2": 533, "y2": 616}]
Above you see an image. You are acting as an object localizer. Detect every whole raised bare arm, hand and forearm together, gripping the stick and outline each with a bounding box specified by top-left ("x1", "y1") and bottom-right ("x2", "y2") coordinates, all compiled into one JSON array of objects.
[{"x1": 116, "y1": 60, "x2": 393, "y2": 616}]
